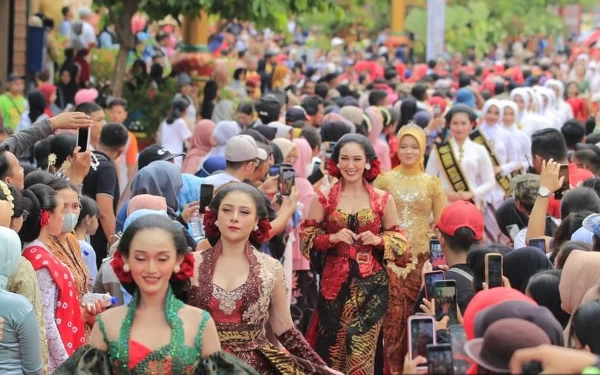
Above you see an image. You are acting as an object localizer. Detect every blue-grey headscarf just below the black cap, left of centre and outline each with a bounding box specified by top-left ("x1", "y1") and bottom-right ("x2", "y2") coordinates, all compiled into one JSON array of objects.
[{"x1": 131, "y1": 160, "x2": 183, "y2": 212}]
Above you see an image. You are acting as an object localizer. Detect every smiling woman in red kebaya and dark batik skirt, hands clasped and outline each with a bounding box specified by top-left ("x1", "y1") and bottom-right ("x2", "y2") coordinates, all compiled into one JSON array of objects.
[{"x1": 302, "y1": 134, "x2": 410, "y2": 375}]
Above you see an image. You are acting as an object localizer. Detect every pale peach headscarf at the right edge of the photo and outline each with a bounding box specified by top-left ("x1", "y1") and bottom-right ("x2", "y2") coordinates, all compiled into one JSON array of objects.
[{"x1": 558, "y1": 250, "x2": 600, "y2": 315}]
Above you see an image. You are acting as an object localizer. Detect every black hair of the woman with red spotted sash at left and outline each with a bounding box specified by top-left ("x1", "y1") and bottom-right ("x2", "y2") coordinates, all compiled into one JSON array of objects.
[{"x1": 19, "y1": 184, "x2": 57, "y2": 243}]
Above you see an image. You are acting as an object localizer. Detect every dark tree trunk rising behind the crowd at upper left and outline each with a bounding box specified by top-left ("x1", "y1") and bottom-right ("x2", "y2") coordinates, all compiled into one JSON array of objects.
[{"x1": 109, "y1": 0, "x2": 141, "y2": 97}]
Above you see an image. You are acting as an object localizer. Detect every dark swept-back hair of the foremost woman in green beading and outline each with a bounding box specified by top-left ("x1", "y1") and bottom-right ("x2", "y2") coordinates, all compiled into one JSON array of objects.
[{"x1": 118, "y1": 214, "x2": 190, "y2": 300}]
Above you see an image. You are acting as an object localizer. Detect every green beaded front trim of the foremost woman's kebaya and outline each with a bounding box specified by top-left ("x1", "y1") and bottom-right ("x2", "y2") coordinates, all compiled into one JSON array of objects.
[{"x1": 111, "y1": 287, "x2": 185, "y2": 374}]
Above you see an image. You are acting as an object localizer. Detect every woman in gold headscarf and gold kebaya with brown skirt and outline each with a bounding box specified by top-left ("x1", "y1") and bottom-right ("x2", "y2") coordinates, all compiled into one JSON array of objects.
[{"x1": 373, "y1": 124, "x2": 446, "y2": 374}]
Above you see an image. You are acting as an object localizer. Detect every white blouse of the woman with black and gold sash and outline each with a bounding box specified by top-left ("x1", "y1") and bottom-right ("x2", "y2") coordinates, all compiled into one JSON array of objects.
[{"x1": 425, "y1": 138, "x2": 496, "y2": 202}]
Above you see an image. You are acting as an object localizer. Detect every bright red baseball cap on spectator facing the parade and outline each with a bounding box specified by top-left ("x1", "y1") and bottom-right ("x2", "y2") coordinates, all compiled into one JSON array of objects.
[{"x1": 436, "y1": 201, "x2": 484, "y2": 240}]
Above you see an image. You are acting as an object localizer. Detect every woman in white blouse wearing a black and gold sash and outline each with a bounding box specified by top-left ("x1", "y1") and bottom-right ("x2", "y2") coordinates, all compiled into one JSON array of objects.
[{"x1": 425, "y1": 105, "x2": 496, "y2": 208}]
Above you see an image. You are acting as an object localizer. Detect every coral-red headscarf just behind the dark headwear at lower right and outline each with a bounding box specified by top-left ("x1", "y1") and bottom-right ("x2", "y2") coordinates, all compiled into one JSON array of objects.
[{"x1": 463, "y1": 288, "x2": 539, "y2": 340}]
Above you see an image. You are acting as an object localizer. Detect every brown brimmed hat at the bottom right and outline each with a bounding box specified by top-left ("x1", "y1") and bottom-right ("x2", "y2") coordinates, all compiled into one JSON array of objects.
[{"x1": 465, "y1": 318, "x2": 550, "y2": 374}]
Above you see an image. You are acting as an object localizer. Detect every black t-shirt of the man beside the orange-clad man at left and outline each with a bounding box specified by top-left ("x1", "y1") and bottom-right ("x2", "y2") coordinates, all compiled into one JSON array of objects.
[{"x1": 82, "y1": 151, "x2": 120, "y2": 268}]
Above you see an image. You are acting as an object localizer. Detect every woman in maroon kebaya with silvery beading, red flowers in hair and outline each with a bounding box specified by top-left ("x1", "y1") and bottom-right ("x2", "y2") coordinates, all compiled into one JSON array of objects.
[{"x1": 188, "y1": 182, "x2": 338, "y2": 375}]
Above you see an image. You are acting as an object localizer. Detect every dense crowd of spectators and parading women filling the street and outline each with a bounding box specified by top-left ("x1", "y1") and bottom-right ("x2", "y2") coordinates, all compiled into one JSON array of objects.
[{"x1": 0, "y1": 5, "x2": 600, "y2": 375}]
